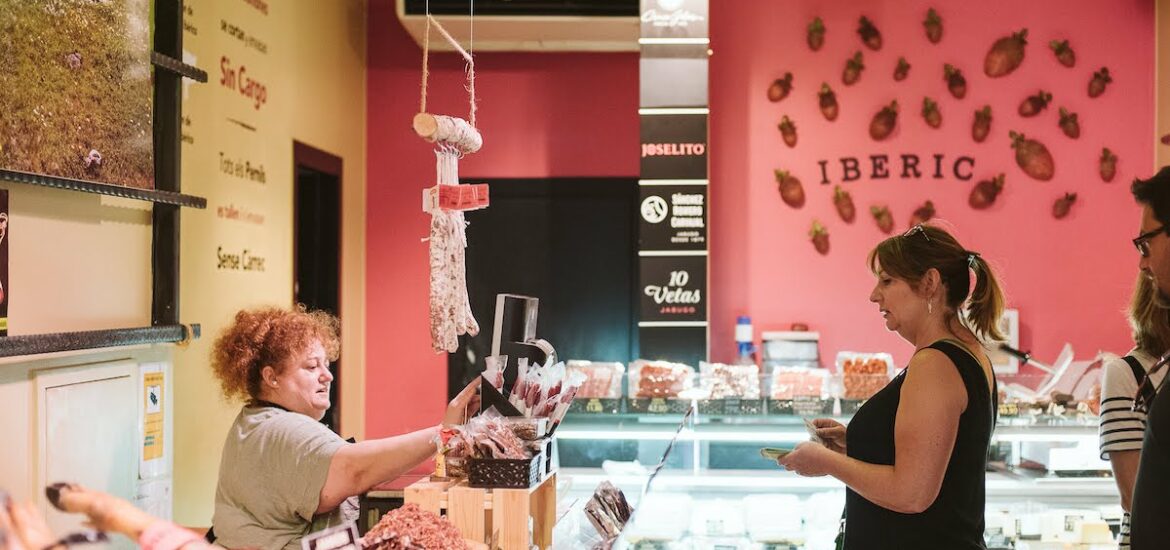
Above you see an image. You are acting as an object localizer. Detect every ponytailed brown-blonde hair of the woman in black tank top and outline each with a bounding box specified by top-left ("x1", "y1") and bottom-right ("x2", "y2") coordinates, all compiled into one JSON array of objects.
[{"x1": 868, "y1": 224, "x2": 1004, "y2": 341}]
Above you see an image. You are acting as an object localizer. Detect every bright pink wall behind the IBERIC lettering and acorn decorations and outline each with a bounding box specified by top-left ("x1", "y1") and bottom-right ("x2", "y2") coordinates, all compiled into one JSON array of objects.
[{"x1": 710, "y1": 0, "x2": 1155, "y2": 363}]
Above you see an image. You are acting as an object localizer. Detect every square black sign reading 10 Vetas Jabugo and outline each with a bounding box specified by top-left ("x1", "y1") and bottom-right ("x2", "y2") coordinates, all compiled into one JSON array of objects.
[{"x1": 639, "y1": 256, "x2": 707, "y2": 322}]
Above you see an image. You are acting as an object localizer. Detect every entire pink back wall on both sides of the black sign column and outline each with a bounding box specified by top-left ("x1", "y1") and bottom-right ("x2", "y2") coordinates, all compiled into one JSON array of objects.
[{"x1": 366, "y1": 0, "x2": 1154, "y2": 436}]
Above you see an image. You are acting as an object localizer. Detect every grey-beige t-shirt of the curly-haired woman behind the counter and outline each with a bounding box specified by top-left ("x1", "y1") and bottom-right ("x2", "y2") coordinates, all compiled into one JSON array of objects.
[{"x1": 212, "y1": 406, "x2": 356, "y2": 550}]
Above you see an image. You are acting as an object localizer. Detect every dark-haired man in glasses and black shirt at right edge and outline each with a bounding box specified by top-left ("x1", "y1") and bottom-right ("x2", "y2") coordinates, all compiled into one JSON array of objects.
[{"x1": 1129, "y1": 166, "x2": 1170, "y2": 550}]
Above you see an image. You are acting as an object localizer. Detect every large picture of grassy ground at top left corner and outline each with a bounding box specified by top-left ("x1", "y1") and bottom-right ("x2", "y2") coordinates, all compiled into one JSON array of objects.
[{"x1": 0, "y1": 0, "x2": 154, "y2": 188}]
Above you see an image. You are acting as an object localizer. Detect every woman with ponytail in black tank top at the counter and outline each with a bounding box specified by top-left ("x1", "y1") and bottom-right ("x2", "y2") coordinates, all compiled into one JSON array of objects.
[{"x1": 779, "y1": 225, "x2": 1004, "y2": 550}]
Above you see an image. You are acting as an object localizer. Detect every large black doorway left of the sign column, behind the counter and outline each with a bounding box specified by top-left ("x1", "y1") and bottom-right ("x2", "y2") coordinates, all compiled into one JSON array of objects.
[{"x1": 447, "y1": 178, "x2": 638, "y2": 396}]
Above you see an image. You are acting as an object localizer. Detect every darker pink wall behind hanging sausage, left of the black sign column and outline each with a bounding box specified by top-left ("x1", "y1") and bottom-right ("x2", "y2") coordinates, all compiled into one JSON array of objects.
[{"x1": 366, "y1": 0, "x2": 638, "y2": 438}]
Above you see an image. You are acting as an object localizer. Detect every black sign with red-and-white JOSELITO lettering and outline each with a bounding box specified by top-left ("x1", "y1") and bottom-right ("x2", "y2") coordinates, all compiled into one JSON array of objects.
[{"x1": 641, "y1": 115, "x2": 707, "y2": 179}]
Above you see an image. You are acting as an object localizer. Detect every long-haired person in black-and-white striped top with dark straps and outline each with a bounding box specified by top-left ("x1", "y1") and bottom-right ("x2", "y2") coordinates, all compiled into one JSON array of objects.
[{"x1": 1099, "y1": 275, "x2": 1170, "y2": 550}]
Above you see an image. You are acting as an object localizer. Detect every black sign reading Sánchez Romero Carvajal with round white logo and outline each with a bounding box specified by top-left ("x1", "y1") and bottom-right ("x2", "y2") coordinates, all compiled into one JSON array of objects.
[{"x1": 638, "y1": 185, "x2": 707, "y2": 250}]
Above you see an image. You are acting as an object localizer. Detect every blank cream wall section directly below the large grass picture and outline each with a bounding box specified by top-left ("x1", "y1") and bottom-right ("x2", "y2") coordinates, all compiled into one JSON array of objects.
[{"x1": 0, "y1": 187, "x2": 151, "y2": 335}]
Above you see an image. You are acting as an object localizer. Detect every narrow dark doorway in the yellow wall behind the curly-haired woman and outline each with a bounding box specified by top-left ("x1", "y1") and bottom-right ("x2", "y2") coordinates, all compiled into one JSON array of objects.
[{"x1": 293, "y1": 142, "x2": 342, "y2": 432}]
